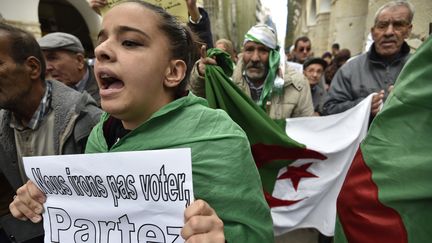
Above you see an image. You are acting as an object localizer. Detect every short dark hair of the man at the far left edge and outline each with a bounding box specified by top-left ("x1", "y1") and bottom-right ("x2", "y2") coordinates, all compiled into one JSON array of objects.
[{"x1": 0, "y1": 22, "x2": 46, "y2": 80}]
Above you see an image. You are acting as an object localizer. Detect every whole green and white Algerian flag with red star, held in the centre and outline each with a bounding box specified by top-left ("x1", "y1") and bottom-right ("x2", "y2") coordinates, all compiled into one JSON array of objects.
[{"x1": 205, "y1": 49, "x2": 371, "y2": 235}]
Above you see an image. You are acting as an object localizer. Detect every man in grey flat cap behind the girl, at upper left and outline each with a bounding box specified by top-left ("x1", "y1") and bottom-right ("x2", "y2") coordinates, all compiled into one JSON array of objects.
[{"x1": 38, "y1": 32, "x2": 100, "y2": 106}]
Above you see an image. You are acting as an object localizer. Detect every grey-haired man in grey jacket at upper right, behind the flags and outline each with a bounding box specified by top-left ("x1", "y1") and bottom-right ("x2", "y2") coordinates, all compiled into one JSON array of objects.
[{"x1": 322, "y1": 1, "x2": 414, "y2": 116}]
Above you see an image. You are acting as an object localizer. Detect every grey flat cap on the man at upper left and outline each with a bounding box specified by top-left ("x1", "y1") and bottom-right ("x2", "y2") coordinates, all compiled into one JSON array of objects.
[{"x1": 38, "y1": 32, "x2": 84, "y2": 53}]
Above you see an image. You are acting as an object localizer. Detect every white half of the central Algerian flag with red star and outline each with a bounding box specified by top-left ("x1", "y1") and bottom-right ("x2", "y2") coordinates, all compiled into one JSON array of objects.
[{"x1": 272, "y1": 95, "x2": 372, "y2": 236}]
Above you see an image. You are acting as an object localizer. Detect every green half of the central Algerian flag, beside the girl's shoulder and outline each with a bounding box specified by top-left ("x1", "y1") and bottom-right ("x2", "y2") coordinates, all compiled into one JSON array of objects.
[{"x1": 205, "y1": 48, "x2": 324, "y2": 204}]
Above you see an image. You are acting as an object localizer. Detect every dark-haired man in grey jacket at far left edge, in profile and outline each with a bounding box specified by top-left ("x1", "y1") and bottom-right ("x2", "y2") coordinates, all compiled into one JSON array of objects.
[{"x1": 0, "y1": 23, "x2": 101, "y2": 243}]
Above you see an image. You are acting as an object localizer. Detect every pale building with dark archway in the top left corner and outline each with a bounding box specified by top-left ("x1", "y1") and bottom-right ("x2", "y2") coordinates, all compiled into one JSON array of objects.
[{"x1": 0, "y1": 0, "x2": 101, "y2": 57}]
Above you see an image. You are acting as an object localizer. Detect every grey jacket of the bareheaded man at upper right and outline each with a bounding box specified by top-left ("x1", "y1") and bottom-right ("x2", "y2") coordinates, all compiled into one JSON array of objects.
[{"x1": 321, "y1": 43, "x2": 410, "y2": 115}]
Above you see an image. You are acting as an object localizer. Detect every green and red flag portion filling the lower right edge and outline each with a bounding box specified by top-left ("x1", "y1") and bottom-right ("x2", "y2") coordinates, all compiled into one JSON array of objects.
[{"x1": 335, "y1": 37, "x2": 432, "y2": 243}]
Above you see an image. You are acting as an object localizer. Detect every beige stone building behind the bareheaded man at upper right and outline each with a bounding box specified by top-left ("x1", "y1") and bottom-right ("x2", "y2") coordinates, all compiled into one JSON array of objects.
[{"x1": 288, "y1": 0, "x2": 432, "y2": 56}]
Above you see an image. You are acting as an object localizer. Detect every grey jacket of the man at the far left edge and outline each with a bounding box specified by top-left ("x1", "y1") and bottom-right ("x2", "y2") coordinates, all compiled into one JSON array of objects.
[{"x1": 0, "y1": 81, "x2": 102, "y2": 242}]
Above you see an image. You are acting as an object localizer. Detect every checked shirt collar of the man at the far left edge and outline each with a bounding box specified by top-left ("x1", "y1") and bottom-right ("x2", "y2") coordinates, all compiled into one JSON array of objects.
[{"x1": 9, "y1": 81, "x2": 52, "y2": 130}]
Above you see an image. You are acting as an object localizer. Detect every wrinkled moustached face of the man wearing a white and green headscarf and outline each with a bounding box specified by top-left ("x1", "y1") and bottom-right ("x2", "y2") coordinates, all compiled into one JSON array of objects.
[{"x1": 243, "y1": 41, "x2": 270, "y2": 85}]
